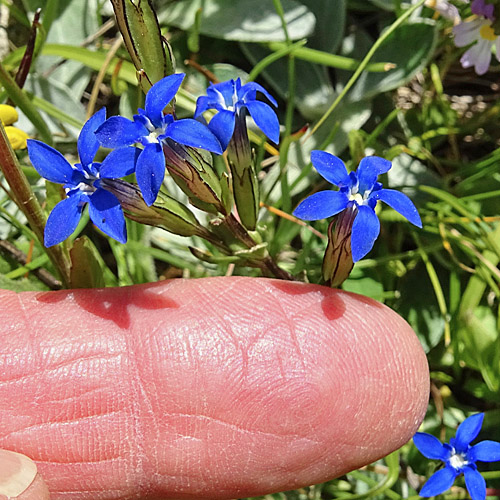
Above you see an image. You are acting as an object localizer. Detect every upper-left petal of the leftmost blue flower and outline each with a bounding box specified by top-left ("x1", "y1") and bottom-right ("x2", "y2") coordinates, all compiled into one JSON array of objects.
[{"x1": 27, "y1": 139, "x2": 74, "y2": 184}]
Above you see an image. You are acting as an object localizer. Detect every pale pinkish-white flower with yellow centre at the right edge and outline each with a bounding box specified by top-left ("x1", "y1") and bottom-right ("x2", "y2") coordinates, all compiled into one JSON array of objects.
[{"x1": 453, "y1": 13, "x2": 500, "y2": 75}]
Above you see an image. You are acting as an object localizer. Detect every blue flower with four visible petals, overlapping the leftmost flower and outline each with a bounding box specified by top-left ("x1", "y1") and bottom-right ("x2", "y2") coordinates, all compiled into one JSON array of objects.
[{"x1": 96, "y1": 73, "x2": 222, "y2": 205}]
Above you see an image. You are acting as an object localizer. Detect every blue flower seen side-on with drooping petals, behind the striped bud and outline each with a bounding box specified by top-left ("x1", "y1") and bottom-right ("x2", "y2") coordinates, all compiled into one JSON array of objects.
[{"x1": 194, "y1": 78, "x2": 280, "y2": 149}]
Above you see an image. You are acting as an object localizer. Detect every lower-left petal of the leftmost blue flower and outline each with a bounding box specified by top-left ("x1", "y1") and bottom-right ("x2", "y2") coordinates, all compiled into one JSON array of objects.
[{"x1": 44, "y1": 192, "x2": 84, "y2": 247}]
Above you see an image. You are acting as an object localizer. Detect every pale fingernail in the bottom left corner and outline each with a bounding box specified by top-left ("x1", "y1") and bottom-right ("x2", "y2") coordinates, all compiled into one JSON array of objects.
[{"x1": 0, "y1": 450, "x2": 37, "y2": 498}]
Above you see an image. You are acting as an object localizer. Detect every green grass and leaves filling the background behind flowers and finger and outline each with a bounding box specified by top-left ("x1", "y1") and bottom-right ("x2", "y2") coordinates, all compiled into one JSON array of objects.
[{"x1": 0, "y1": 0, "x2": 500, "y2": 499}]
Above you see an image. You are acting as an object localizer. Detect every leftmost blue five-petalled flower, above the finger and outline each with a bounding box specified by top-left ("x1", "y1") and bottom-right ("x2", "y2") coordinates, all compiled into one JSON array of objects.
[{"x1": 28, "y1": 108, "x2": 139, "y2": 247}]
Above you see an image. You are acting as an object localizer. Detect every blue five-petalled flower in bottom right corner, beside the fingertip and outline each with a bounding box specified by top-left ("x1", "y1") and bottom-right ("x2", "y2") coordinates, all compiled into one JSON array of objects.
[{"x1": 413, "y1": 413, "x2": 500, "y2": 500}]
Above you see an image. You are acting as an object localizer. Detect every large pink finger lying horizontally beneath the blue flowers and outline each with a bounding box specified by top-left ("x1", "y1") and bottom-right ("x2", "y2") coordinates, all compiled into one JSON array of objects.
[{"x1": 0, "y1": 277, "x2": 429, "y2": 500}]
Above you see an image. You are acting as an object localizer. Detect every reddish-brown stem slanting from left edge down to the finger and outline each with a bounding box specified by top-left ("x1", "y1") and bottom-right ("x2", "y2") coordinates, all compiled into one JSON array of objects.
[{"x1": 0, "y1": 123, "x2": 70, "y2": 287}]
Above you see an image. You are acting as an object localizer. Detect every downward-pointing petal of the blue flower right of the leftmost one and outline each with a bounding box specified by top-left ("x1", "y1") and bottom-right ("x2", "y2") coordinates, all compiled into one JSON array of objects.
[{"x1": 135, "y1": 143, "x2": 165, "y2": 205}]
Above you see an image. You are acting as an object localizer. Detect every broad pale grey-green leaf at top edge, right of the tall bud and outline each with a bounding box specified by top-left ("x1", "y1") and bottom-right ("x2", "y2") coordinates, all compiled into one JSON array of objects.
[{"x1": 159, "y1": 0, "x2": 315, "y2": 42}]
